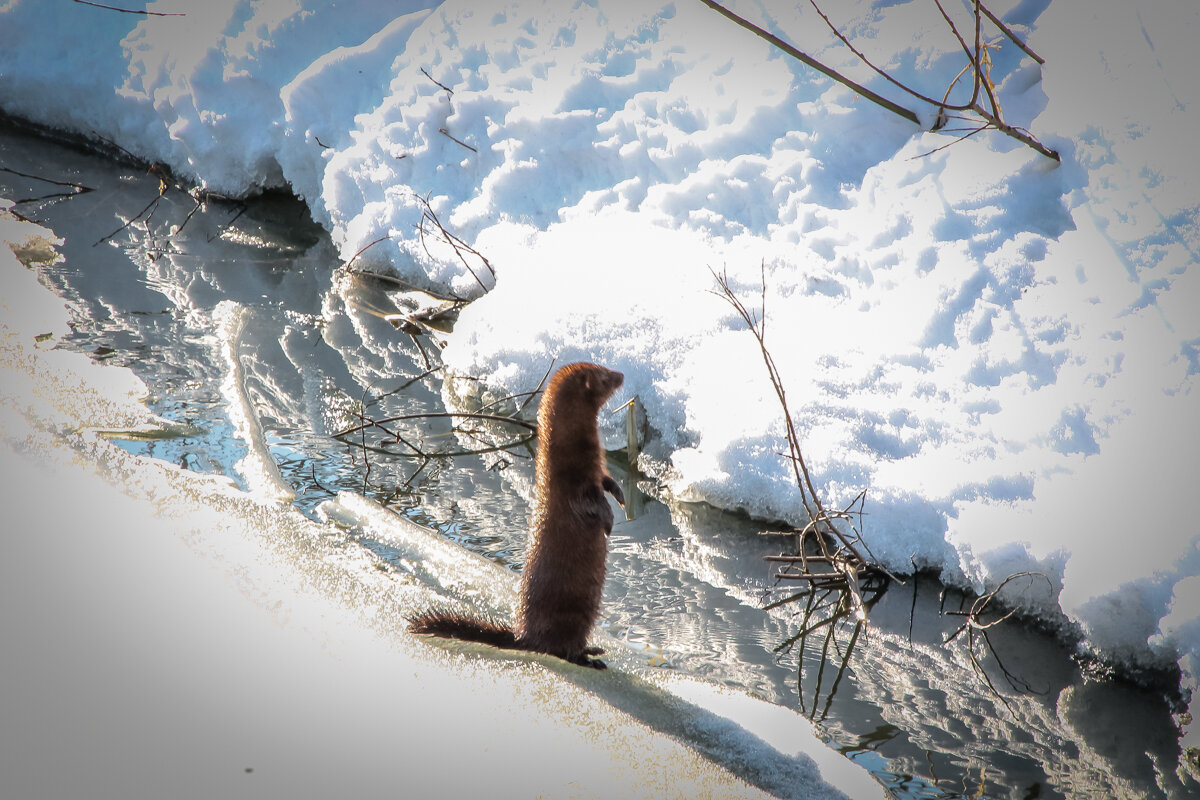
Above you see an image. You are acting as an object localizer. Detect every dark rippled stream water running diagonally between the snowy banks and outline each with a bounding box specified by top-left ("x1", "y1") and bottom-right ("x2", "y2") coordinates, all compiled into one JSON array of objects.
[{"x1": 0, "y1": 118, "x2": 1200, "y2": 798}]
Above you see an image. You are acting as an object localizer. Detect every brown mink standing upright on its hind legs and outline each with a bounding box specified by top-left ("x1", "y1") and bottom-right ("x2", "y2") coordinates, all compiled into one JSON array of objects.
[{"x1": 409, "y1": 363, "x2": 625, "y2": 669}]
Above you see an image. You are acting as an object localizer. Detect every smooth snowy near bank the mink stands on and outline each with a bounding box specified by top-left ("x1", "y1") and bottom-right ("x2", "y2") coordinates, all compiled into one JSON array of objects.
[{"x1": 0, "y1": 203, "x2": 881, "y2": 799}]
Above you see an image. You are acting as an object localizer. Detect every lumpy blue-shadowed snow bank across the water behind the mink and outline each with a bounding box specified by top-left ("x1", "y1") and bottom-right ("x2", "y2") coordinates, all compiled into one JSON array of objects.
[{"x1": 0, "y1": 0, "x2": 1200, "y2": 690}]
